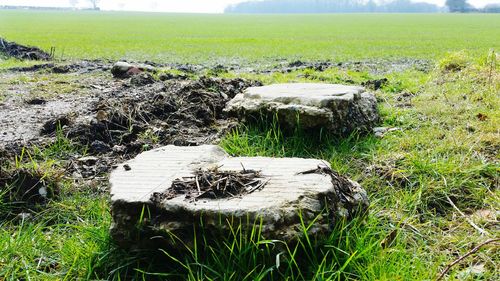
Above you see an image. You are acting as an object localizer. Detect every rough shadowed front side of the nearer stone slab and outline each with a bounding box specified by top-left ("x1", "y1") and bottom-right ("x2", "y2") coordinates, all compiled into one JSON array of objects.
[{"x1": 111, "y1": 174, "x2": 369, "y2": 249}]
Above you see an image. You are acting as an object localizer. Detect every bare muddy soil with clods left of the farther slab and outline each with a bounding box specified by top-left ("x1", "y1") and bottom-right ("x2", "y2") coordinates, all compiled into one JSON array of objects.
[{"x1": 0, "y1": 61, "x2": 259, "y2": 182}]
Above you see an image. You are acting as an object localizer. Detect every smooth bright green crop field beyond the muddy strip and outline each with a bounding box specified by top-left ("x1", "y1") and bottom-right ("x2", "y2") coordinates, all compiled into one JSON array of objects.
[{"x1": 0, "y1": 10, "x2": 500, "y2": 63}]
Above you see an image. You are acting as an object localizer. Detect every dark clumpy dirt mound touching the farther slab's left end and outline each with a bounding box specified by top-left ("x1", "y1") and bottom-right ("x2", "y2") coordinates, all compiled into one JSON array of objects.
[{"x1": 67, "y1": 78, "x2": 256, "y2": 153}]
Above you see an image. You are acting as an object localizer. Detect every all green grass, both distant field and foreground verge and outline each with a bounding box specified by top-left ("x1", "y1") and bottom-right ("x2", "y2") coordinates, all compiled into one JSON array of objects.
[{"x1": 0, "y1": 11, "x2": 500, "y2": 281}]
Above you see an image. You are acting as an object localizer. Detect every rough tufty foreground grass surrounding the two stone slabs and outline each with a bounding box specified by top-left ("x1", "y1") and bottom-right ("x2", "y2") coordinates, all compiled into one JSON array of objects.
[{"x1": 0, "y1": 52, "x2": 500, "y2": 280}]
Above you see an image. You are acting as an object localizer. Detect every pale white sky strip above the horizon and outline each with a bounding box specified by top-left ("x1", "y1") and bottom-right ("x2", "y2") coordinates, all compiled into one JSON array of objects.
[{"x1": 0, "y1": 0, "x2": 500, "y2": 13}]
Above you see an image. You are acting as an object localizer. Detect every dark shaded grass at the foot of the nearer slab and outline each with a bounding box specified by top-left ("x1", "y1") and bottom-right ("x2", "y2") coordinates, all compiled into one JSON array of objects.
[{"x1": 88, "y1": 213, "x2": 376, "y2": 280}]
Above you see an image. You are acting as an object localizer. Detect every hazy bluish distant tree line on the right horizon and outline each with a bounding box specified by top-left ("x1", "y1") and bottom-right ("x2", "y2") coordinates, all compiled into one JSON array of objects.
[{"x1": 224, "y1": 0, "x2": 500, "y2": 13}]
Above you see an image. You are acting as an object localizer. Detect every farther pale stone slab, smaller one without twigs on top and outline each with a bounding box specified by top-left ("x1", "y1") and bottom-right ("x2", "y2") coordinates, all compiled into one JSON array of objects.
[{"x1": 225, "y1": 83, "x2": 379, "y2": 135}]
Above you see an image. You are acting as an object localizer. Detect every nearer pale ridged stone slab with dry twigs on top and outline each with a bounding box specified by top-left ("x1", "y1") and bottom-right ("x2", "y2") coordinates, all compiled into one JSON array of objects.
[{"x1": 110, "y1": 145, "x2": 368, "y2": 248}]
